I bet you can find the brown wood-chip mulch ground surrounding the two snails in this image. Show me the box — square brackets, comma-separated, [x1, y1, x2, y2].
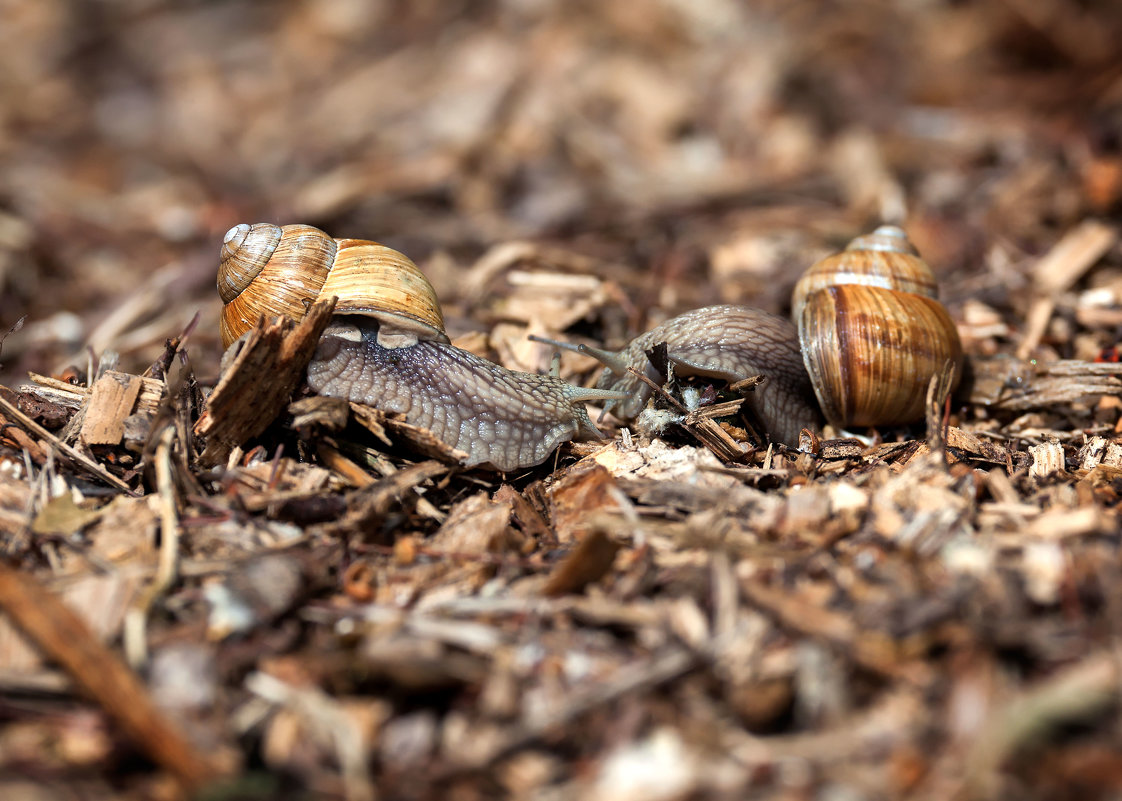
[0, 0, 1122, 801]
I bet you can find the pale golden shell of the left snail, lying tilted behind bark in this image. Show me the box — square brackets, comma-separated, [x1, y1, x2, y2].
[218, 223, 448, 348]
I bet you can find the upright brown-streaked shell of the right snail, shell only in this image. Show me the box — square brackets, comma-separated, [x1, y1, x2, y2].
[792, 225, 963, 426]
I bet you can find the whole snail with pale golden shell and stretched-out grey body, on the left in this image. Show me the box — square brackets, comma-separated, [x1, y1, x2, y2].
[218, 223, 624, 470]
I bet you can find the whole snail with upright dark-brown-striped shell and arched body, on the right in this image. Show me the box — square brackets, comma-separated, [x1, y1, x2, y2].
[535, 225, 963, 445]
